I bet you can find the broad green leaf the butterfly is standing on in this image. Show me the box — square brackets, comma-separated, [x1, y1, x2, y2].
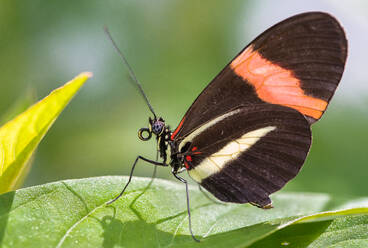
[0, 177, 368, 248]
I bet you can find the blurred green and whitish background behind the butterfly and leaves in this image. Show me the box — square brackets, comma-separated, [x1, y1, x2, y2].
[0, 0, 368, 196]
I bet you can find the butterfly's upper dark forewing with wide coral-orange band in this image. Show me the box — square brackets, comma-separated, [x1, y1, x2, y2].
[171, 12, 347, 140]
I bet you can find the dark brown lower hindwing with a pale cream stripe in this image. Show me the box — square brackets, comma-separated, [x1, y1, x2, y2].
[180, 103, 311, 206]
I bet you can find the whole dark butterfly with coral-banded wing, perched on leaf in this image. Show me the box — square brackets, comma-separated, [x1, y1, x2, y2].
[105, 12, 347, 239]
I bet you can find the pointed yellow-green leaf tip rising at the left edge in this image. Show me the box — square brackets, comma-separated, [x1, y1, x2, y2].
[0, 73, 92, 193]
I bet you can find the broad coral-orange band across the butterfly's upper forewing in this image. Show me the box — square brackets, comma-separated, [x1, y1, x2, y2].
[230, 46, 328, 119]
